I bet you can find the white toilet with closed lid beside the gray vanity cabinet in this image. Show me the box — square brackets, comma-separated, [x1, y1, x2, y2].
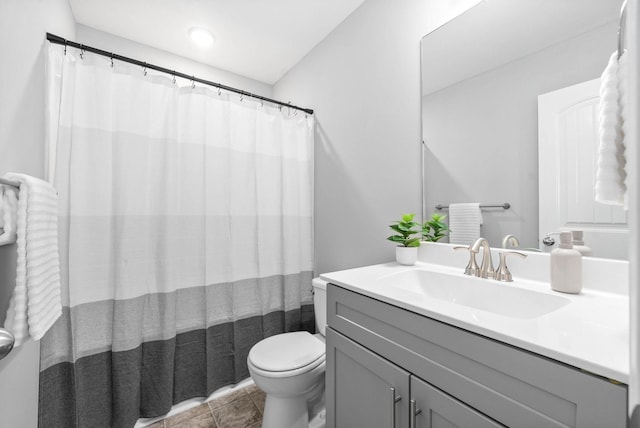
[247, 278, 327, 428]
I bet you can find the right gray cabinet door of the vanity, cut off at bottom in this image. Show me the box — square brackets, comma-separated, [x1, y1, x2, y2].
[409, 376, 504, 428]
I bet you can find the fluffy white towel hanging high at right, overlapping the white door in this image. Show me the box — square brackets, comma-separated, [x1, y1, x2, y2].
[595, 52, 628, 208]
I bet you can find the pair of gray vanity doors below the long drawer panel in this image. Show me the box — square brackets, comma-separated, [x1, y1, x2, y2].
[326, 328, 502, 428]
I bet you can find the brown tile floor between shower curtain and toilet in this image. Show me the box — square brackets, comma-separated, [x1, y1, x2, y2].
[147, 385, 265, 428]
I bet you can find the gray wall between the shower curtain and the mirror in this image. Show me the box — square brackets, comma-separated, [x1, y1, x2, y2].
[274, 0, 477, 273]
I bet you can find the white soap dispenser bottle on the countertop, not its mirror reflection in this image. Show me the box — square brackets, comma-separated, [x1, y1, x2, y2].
[551, 232, 582, 294]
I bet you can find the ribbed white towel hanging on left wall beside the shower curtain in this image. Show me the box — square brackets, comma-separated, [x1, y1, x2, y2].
[4, 173, 62, 346]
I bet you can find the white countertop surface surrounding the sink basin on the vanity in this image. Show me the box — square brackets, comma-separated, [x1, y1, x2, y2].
[320, 262, 629, 384]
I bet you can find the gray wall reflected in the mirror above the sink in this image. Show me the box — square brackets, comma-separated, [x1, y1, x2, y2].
[422, 23, 617, 247]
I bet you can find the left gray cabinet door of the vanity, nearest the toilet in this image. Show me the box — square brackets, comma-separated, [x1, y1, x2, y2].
[326, 328, 409, 428]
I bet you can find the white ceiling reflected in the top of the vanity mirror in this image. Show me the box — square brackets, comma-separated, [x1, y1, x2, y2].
[422, 0, 622, 95]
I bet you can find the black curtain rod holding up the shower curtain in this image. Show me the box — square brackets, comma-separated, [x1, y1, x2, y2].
[47, 33, 313, 114]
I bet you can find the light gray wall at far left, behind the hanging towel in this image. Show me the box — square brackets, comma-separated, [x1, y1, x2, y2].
[0, 0, 75, 428]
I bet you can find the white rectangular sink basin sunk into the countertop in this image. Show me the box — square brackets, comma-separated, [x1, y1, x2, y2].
[379, 269, 571, 319]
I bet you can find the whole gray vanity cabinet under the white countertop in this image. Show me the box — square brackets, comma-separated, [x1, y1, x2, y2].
[326, 284, 627, 428]
